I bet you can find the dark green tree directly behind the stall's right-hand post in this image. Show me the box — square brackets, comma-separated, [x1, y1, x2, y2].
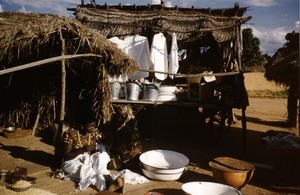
[242, 28, 265, 67]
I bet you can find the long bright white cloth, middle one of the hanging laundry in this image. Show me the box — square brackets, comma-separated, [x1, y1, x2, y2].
[150, 33, 168, 80]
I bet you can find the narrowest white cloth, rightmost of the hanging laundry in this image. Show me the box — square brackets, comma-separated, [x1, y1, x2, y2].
[169, 33, 179, 78]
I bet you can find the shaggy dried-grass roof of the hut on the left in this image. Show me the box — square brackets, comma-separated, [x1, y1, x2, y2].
[0, 12, 138, 74]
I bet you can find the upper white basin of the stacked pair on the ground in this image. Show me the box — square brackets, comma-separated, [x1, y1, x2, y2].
[139, 150, 189, 174]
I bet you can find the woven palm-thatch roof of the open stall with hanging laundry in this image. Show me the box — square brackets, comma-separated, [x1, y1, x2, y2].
[70, 4, 251, 45]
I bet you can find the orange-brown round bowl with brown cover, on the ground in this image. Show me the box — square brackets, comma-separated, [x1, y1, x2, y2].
[209, 157, 255, 188]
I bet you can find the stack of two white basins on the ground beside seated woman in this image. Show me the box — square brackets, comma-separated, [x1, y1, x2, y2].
[140, 150, 189, 181]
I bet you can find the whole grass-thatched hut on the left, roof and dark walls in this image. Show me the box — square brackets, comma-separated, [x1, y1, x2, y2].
[0, 12, 138, 131]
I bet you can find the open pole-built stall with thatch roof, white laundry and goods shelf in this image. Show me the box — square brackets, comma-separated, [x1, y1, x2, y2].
[69, 1, 251, 153]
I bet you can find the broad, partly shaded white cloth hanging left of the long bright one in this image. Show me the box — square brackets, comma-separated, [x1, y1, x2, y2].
[124, 35, 152, 80]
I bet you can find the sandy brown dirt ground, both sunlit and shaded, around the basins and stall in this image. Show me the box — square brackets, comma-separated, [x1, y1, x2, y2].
[0, 98, 300, 195]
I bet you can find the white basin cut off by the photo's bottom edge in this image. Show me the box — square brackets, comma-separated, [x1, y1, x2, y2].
[181, 181, 243, 195]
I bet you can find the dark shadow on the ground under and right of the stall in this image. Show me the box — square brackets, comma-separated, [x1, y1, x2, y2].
[141, 106, 300, 194]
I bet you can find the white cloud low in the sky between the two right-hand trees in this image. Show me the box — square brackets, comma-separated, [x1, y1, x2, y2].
[251, 26, 293, 55]
